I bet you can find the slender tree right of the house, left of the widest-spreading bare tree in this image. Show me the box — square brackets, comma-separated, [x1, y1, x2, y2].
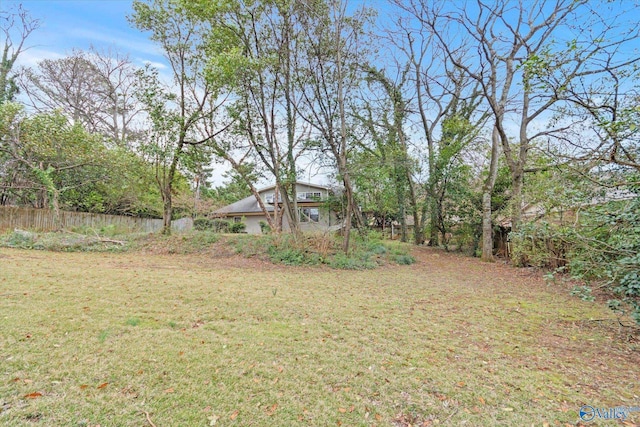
[386, 10, 486, 245]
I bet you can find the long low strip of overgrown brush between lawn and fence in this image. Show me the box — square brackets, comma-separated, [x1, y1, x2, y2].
[0, 228, 415, 270]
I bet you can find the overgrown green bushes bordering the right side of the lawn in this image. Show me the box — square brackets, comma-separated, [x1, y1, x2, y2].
[511, 180, 640, 324]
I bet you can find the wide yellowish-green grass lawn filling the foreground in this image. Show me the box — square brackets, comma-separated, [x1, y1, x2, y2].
[0, 249, 640, 427]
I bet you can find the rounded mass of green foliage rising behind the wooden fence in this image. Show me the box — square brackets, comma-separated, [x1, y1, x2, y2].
[0, 103, 159, 216]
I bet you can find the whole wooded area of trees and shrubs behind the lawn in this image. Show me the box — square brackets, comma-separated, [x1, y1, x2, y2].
[0, 0, 640, 319]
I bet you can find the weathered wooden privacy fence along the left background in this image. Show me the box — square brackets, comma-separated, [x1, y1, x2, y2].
[0, 206, 193, 233]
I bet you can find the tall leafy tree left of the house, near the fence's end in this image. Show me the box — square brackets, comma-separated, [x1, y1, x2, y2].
[130, 0, 234, 234]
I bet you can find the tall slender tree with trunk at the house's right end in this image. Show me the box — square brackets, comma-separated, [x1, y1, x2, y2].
[296, 0, 370, 252]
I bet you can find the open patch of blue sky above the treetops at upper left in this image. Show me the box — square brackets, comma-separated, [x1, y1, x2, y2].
[1, 0, 168, 67]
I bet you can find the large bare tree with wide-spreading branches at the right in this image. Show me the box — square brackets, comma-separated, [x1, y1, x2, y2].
[423, 0, 638, 237]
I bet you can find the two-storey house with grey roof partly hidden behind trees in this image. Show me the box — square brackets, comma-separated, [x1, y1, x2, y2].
[212, 182, 339, 234]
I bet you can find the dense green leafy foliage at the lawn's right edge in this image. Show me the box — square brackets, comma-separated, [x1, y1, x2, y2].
[513, 172, 640, 323]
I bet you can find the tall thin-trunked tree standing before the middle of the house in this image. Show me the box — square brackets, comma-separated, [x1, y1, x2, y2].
[220, 1, 309, 237]
